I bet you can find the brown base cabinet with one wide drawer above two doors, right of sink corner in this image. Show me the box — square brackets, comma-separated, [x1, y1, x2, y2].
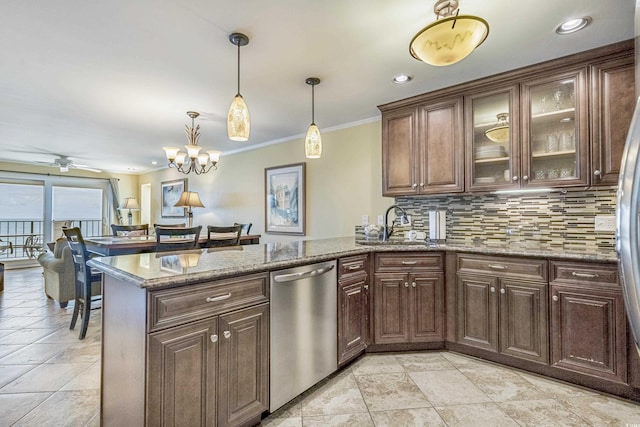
[457, 254, 549, 363]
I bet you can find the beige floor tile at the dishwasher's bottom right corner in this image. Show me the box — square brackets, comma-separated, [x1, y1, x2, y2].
[302, 374, 367, 417]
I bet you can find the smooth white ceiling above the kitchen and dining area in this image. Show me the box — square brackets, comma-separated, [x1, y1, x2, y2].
[0, 0, 634, 173]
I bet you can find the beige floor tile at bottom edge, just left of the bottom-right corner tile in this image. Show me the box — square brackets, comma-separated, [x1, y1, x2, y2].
[499, 399, 596, 427]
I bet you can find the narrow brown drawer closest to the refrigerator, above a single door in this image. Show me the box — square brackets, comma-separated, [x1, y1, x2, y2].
[550, 261, 620, 287]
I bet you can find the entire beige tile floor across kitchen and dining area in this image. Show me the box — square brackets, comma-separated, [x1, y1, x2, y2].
[0, 268, 640, 427]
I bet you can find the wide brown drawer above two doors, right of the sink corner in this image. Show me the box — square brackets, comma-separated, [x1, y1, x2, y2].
[458, 254, 549, 281]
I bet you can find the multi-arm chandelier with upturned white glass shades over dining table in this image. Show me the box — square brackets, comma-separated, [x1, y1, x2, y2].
[162, 111, 220, 175]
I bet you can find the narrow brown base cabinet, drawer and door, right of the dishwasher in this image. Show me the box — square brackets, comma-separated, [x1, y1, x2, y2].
[338, 255, 369, 366]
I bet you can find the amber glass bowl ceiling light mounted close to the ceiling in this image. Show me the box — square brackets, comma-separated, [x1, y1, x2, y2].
[409, 0, 489, 66]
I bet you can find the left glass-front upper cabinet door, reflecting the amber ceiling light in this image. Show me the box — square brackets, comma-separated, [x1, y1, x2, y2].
[465, 85, 520, 191]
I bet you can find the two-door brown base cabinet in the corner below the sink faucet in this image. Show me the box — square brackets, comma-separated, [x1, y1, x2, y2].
[374, 253, 444, 344]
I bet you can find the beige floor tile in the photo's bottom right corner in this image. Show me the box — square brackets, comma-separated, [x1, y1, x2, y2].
[561, 395, 640, 427]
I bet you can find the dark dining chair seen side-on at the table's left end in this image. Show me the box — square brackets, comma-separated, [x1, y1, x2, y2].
[62, 227, 102, 340]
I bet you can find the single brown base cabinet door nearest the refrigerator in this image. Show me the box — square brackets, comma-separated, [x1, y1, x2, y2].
[551, 285, 627, 382]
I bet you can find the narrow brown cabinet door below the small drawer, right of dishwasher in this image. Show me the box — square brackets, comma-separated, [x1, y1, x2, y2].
[338, 273, 367, 365]
